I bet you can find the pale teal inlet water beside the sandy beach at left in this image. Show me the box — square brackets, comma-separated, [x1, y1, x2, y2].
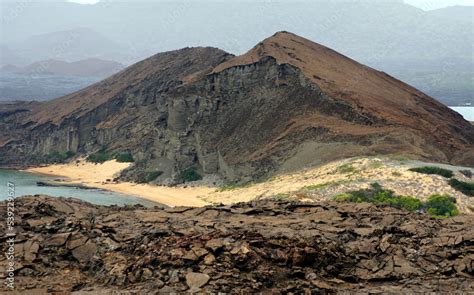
[0, 169, 156, 206]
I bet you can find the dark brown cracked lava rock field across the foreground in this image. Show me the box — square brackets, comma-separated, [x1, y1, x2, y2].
[0, 196, 474, 294]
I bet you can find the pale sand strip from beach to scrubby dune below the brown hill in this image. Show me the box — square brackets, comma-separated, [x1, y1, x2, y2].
[27, 157, 474, 214]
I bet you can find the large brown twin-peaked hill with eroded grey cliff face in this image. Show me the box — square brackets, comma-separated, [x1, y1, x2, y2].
[0, 32, 474, 182]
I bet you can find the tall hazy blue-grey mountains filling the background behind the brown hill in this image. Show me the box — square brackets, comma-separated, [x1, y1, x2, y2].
[0, 0, 474, 105]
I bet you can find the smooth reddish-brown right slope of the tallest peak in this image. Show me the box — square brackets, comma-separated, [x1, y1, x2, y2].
[214, 32, 472, 155]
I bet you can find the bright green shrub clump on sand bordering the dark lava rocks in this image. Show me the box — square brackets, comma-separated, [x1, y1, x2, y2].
[333, 183, 459, 218]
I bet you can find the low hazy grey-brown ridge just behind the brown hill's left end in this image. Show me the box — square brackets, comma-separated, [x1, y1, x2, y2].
[0, 58, 125, 77]
